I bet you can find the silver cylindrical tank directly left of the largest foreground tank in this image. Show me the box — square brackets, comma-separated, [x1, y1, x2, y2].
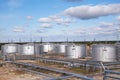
[65, 44, 86, 58]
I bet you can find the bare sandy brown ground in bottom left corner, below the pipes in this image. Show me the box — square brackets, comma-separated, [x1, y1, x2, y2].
[0, 66, 48, 80]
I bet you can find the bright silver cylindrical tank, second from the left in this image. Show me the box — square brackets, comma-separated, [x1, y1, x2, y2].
[21, 43, 35, 55]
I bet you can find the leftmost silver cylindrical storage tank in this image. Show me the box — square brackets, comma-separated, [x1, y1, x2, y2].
[2, 44, 18, 54]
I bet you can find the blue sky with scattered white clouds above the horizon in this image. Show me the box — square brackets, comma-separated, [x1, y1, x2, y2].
[0, 0, 120, 42]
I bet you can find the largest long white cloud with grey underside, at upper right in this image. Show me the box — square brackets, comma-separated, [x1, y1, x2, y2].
[64, 4, 120, 20]
